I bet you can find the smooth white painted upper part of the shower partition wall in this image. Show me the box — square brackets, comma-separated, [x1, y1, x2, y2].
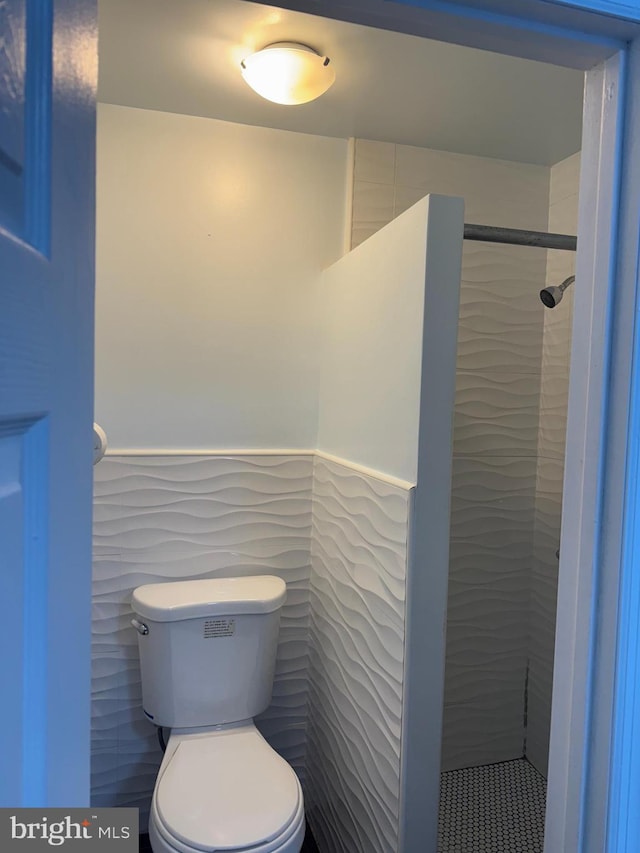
[318, 198, 460, 483]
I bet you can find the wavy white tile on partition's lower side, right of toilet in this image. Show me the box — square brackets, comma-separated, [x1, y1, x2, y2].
[307, 457, 411, 853]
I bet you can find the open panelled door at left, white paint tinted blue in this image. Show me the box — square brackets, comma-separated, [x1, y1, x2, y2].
[0, 0, 96, 807]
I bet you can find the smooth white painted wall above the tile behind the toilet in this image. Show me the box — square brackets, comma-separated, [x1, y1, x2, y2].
[96, 104, 348, 450]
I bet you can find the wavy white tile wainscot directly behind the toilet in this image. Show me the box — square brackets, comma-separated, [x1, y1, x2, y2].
[92, 455, 313, 827]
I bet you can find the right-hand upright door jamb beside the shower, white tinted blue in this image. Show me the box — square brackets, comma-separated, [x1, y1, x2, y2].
[545, 51, 633, 853]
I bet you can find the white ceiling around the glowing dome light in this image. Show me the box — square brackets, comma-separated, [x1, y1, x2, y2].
[98, 0, 583, 165]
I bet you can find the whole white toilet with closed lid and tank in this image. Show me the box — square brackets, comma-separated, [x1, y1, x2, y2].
[132, 576, 305, 853]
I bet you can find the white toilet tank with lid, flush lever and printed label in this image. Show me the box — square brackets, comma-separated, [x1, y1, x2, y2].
[132, 575, 286, 728]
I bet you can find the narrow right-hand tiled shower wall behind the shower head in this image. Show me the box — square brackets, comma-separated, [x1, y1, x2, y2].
[527, 154, 580, 776]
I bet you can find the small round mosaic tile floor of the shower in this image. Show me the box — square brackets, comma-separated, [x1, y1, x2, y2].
[438, 758, 547, 853]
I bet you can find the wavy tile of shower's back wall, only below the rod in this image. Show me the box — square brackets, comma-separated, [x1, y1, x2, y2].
[442, 244, 546, 770]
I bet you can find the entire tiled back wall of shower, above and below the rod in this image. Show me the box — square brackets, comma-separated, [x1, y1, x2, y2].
[352, 140, 549, 770]
